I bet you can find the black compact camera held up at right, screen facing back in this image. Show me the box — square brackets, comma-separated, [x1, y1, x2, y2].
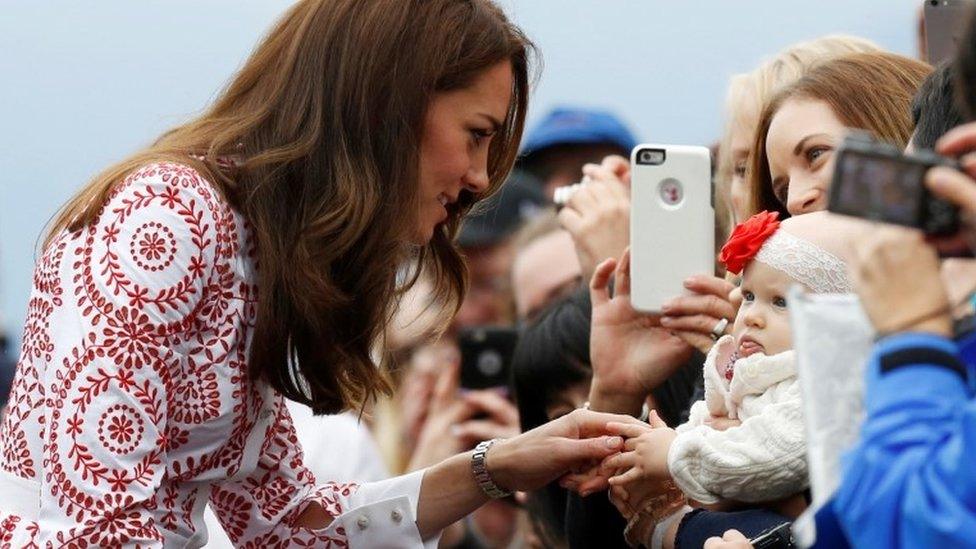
[827, 132, 959, 236]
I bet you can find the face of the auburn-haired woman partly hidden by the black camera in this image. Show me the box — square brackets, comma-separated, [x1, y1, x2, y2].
[766, 99, 847, 215]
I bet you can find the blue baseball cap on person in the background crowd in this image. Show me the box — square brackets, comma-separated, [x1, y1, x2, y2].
[521, 107, 637, 156]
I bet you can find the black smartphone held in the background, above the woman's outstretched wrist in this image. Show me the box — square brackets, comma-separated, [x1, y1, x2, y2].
[458, 326, 518, 389]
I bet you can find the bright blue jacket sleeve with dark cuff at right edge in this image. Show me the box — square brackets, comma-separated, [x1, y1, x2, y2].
[834, 334, 976, 548]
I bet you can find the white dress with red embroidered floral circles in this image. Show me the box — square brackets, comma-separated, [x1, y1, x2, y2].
[0, 164, 437, 549]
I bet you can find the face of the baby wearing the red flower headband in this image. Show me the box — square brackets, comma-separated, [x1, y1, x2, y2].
[732, 261, 793, 357]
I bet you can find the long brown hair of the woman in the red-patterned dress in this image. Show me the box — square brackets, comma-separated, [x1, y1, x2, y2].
[47, 0, 535, 413]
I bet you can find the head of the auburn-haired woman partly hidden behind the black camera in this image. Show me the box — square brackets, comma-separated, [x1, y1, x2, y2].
[749, 53, 932, 217]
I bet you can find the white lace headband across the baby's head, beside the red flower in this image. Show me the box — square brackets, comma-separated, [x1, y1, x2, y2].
[756, 229, 854, 294]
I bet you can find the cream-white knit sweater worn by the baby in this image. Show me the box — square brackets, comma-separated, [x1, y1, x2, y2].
[668, 336, 808, 503]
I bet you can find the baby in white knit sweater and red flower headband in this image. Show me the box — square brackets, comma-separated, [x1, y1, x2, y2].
[606, 212, 852, 544]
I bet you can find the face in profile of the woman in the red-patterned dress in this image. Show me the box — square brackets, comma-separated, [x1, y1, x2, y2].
[414, 61, 513, 245]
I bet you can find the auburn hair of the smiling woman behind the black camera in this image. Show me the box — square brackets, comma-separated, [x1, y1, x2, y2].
[747, 52, 932, 219]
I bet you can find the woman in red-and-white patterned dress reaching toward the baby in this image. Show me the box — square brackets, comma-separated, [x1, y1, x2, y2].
[0, 0, 621, 547]
